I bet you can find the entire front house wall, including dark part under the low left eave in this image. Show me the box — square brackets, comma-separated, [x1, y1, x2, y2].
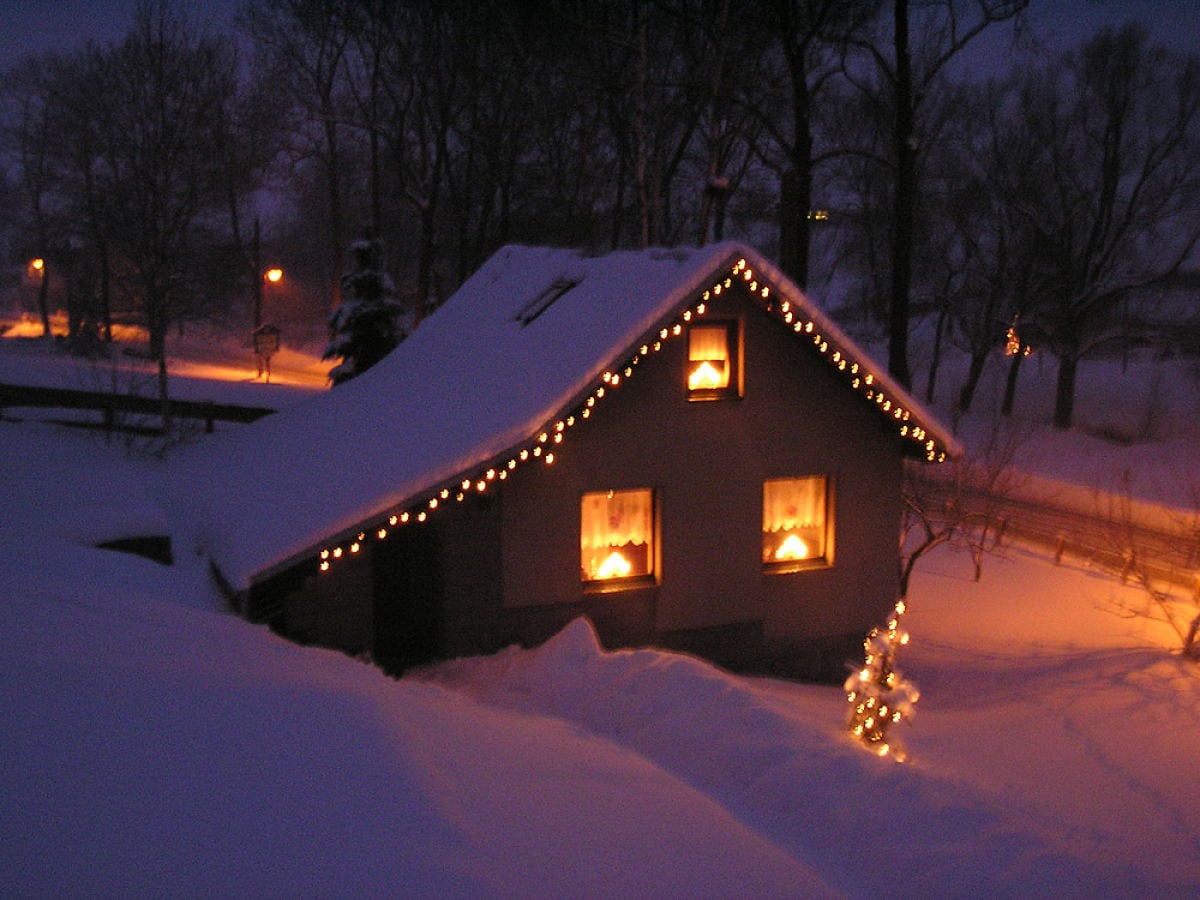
[270, 285, 901, 677]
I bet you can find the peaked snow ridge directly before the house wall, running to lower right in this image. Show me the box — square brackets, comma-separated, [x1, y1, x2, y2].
[427, 620, 1180, 896]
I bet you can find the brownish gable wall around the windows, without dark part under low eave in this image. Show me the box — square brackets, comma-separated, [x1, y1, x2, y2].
[502, 285, 901, 666]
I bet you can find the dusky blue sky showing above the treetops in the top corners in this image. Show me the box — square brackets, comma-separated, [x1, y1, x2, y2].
[0, 0, 1200, 78]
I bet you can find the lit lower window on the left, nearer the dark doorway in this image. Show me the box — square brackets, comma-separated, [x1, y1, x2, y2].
[580, 488, 654, 583]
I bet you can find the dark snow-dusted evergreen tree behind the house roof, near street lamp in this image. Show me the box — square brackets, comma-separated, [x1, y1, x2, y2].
[322, 234, 406, 385]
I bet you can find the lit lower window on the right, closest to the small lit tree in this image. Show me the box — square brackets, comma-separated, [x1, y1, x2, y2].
[762, 475, 832, 571]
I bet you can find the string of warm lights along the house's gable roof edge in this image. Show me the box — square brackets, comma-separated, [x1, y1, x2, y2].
[318, 258, 946, 571]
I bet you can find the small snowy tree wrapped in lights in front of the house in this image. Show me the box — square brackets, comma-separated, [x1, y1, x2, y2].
[846, 600, 919, 762]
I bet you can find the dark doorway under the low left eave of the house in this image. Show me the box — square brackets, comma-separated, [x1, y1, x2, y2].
[373, 524, 444, 674]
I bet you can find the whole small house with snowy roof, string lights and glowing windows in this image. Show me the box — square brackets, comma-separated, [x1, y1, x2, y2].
[184, 244, 958, 680]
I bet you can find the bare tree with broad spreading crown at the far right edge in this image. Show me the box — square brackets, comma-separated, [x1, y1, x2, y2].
[1012, 25, 1200, 428]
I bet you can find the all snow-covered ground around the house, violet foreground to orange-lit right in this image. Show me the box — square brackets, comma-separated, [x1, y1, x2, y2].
[0, 321, 1200, 896]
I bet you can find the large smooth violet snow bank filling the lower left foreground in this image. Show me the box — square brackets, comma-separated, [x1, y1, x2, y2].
[0, 551, 830, 896]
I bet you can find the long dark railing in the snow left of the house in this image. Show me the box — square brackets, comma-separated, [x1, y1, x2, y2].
[0, 384, 275, 432]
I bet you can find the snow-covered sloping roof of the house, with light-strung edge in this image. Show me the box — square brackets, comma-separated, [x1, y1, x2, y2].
[182, 242, 958, 590]
